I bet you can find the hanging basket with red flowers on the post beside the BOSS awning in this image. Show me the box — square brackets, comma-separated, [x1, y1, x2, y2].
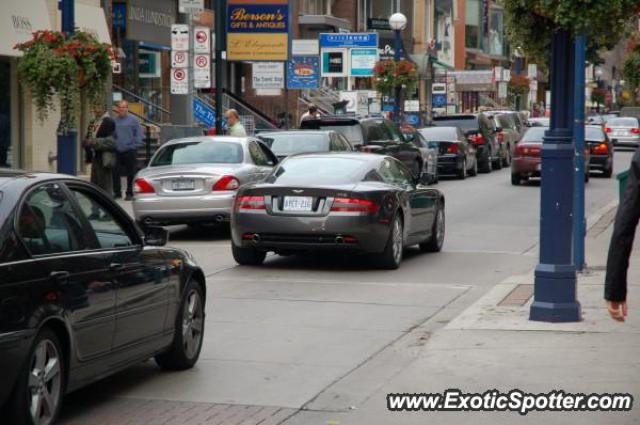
[15, 31, 111, 133]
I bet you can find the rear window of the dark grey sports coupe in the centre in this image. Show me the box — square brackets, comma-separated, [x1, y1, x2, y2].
[267, 156, 368, 186]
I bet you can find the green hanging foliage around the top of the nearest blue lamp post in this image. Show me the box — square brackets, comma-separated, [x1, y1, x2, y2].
[501, 0, 640, 64]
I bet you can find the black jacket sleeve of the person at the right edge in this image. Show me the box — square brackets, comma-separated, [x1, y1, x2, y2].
[604, 150, 640, 301]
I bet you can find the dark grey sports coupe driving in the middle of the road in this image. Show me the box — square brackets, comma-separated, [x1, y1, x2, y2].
[231, 153, 445, 269]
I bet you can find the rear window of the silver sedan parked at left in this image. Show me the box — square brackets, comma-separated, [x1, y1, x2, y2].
[151, 140, 243, 167]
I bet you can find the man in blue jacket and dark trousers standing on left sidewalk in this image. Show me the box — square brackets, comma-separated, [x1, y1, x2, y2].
[113, 100, 142, 201]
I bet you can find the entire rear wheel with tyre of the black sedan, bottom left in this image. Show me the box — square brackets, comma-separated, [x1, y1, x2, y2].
[9, 329, 66, 425]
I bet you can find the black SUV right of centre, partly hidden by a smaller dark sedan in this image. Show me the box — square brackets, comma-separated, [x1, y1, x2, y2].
[433, 113, 502, 173]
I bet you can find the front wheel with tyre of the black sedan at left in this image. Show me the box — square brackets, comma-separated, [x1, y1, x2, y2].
[156, 281, 204, 370]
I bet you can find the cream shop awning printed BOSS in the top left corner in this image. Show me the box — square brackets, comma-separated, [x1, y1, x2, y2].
[0, 0, 52, 56]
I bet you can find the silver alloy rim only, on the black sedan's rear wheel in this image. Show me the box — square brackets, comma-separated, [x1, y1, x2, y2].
[28, 339, 62, 425]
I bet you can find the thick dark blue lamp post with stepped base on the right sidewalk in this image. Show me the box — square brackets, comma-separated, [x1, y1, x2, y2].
[529, 30, 581, 322]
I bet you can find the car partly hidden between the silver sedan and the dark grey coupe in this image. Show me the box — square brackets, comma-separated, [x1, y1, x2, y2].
[258, 130, 353, 160]
